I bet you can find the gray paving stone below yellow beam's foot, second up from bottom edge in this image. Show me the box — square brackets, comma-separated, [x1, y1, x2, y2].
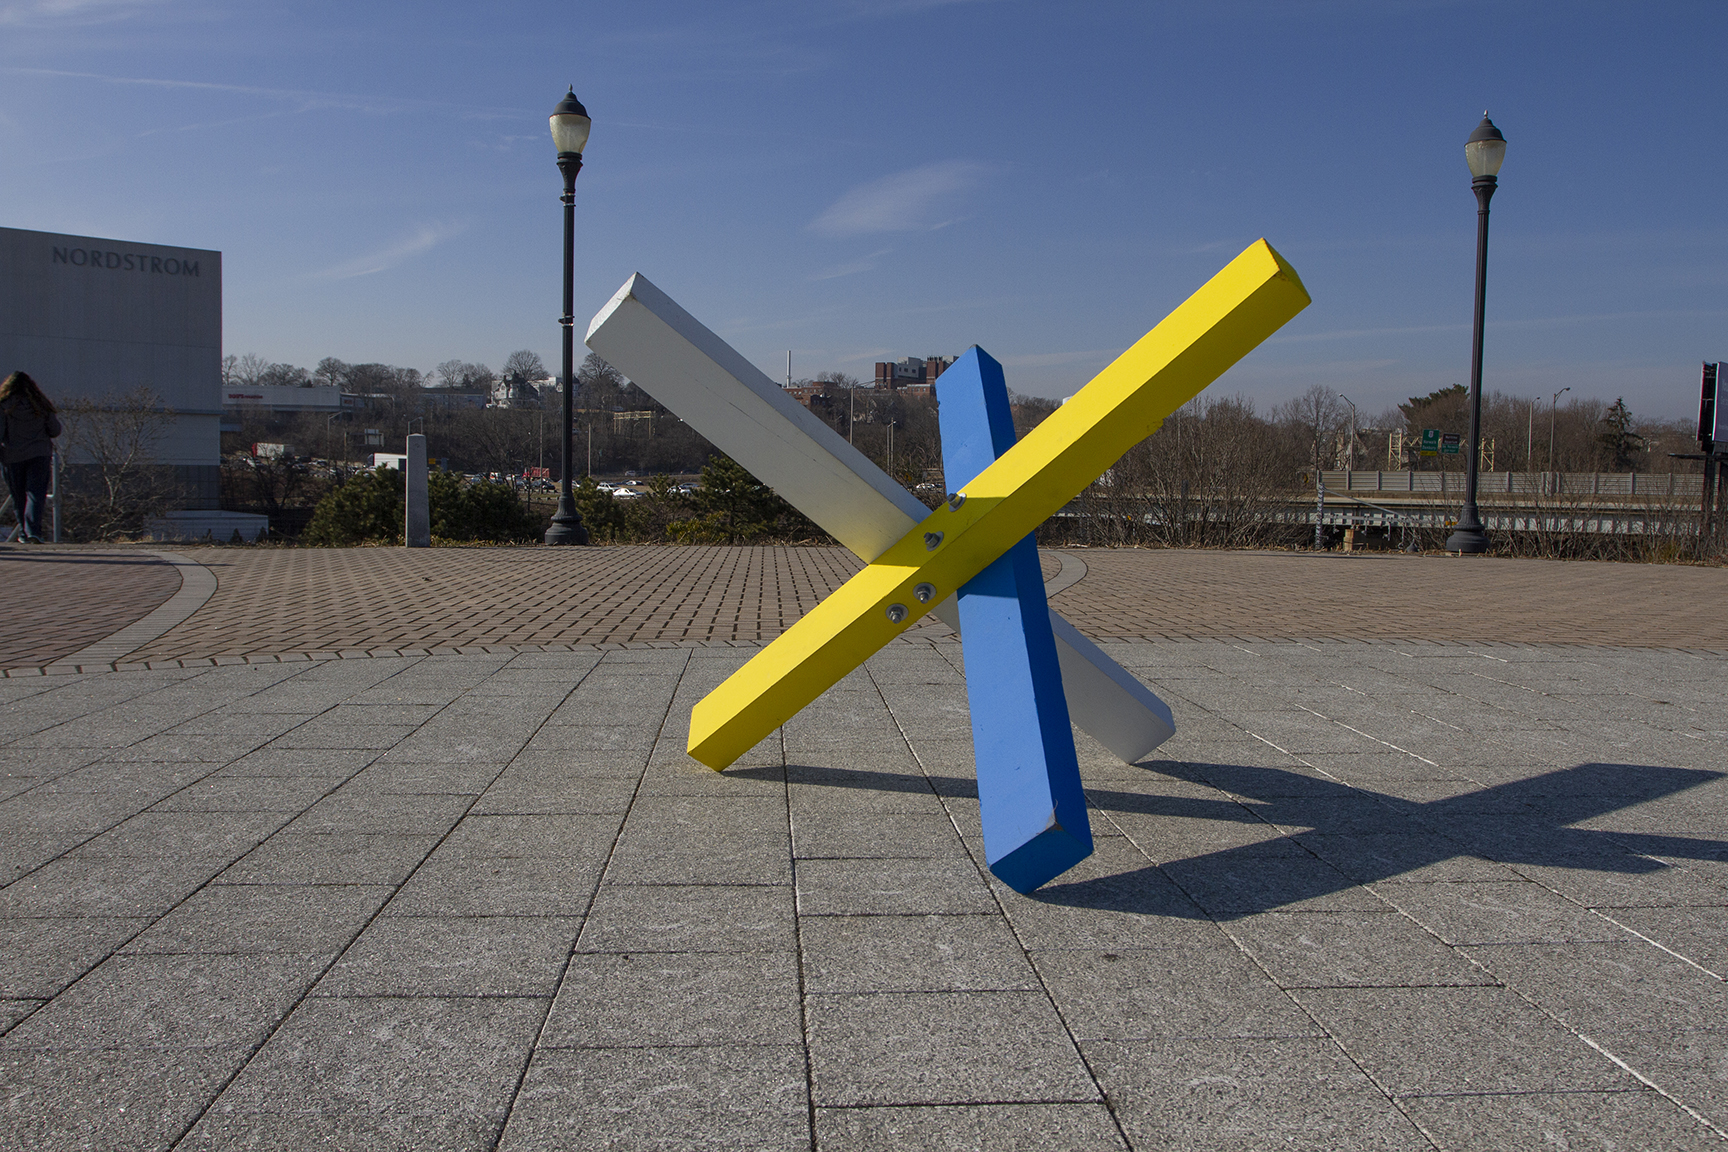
[541, 952, 804, 1048]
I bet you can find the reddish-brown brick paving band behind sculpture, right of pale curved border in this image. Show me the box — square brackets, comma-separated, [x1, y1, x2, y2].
[118, 546, 1728, 661]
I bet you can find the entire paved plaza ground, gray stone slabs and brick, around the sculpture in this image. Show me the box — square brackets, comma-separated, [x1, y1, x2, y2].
[0, 548, 1728, 1152]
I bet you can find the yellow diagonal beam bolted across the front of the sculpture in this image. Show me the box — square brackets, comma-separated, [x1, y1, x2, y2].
[689, 240, 1310, 770]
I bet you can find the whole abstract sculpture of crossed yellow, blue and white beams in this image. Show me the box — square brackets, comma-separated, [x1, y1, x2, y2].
[588, 240, 1308, 891]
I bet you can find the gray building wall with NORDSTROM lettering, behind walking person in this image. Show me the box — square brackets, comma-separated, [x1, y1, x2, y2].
[0, 228, 221, 508]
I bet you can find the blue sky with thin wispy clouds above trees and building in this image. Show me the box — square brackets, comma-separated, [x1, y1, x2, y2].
[0, 0, 1728, 418]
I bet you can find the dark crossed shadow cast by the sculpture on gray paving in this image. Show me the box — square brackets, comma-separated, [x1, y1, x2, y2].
[753, 762, 1728, 919]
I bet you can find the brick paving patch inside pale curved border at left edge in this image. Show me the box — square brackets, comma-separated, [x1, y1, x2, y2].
[0, 544, 180, 668]
